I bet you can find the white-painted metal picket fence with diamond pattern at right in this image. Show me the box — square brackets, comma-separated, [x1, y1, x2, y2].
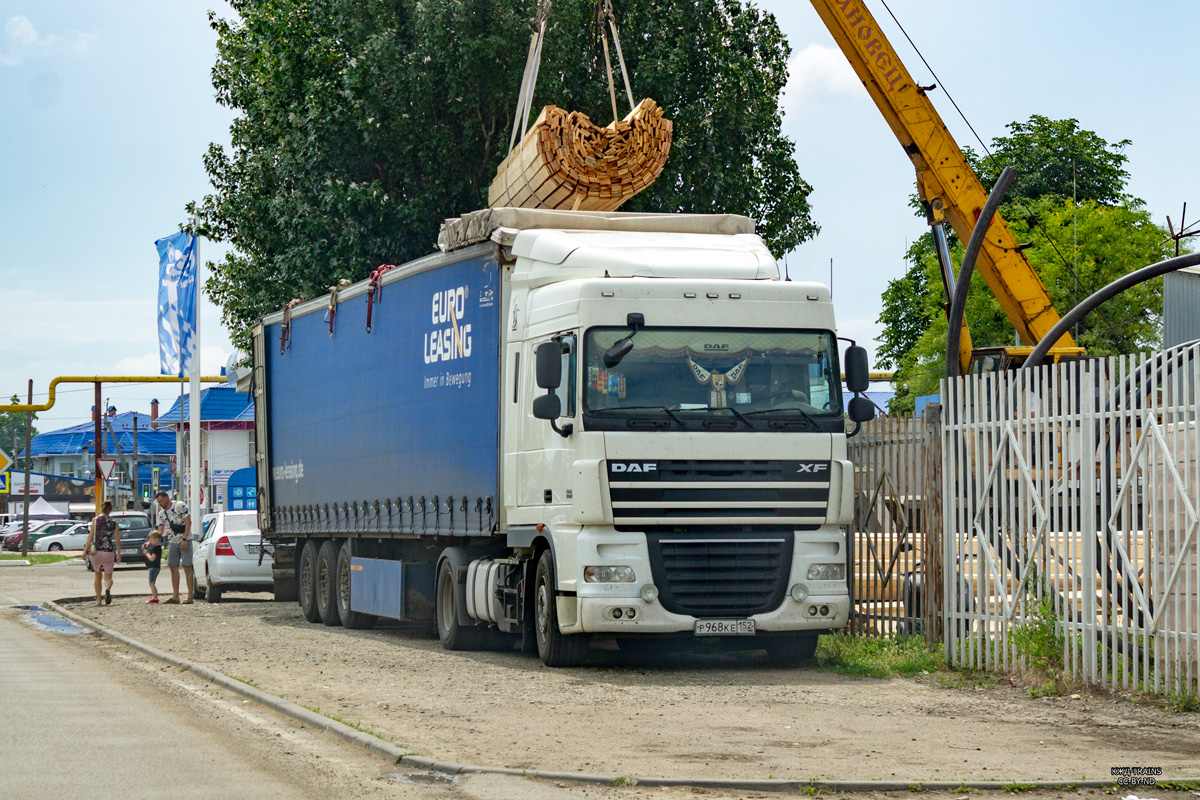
[940, 348, 1200, 694]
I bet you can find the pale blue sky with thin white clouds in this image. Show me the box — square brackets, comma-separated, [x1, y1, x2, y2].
[0, 0, 1200, 445]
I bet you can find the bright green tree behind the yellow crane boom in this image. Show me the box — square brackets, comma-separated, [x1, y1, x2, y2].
[876, 114, 1168, 411]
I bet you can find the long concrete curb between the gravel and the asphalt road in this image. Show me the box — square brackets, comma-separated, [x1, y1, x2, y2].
[47, 595, 1200, 794]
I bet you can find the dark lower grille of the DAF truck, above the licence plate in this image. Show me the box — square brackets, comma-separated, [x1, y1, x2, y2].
[647, 530, 792, 618]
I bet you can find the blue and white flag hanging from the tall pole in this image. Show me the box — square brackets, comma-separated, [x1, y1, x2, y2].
[155, 233, 199, 378]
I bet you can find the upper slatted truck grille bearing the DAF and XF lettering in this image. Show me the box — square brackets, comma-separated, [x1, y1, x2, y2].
[608, 461, 829, 533]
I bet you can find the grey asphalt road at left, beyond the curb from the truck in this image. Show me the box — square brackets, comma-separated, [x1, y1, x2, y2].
[0, 563, 686, 800]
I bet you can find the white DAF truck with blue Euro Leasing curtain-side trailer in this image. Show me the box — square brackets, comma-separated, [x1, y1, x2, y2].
[253, 209, 866, 666]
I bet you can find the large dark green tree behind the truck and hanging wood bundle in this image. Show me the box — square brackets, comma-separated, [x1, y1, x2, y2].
[188, 0, 817, 348]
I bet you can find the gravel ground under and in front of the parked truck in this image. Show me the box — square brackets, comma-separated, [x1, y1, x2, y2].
[65, 595, 1200, 796]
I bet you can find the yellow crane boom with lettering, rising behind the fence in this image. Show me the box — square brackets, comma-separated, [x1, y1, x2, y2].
[812, 0, 1082, 372]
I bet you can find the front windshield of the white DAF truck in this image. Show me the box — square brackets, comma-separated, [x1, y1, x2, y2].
[583, 327, 844, 432]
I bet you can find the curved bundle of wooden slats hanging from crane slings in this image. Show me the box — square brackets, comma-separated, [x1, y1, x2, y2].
[487, 97, 672, 211]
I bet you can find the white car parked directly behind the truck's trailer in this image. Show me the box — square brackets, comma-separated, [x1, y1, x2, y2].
[192, 511, 274, 603]
